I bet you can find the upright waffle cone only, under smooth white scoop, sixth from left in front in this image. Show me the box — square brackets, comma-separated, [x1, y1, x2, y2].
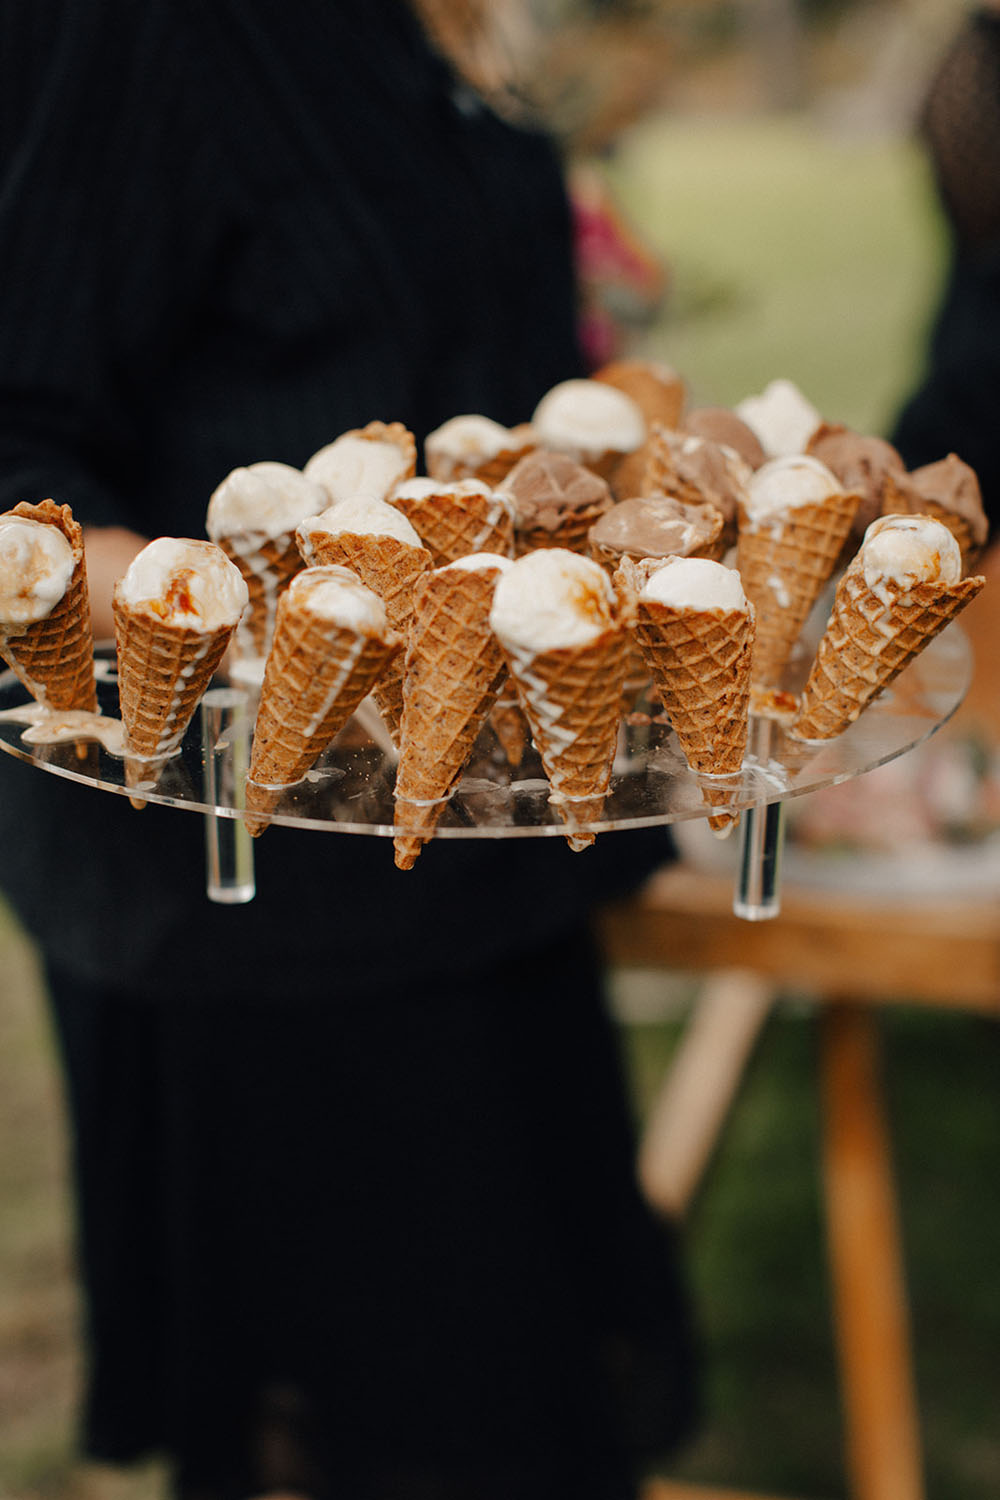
[634, 599, 754, 833]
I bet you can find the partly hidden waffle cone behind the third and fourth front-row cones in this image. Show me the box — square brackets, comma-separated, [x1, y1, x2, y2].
[293, 528, 432, 746]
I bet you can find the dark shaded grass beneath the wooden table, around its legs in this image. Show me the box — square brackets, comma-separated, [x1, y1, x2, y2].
[625, 996, 1000, 1500]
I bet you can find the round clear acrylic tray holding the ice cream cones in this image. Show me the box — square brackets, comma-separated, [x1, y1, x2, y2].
[0, 624, 972, 839]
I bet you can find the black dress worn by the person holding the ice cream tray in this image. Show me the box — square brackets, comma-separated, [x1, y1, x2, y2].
[0, 0, 691, 1500]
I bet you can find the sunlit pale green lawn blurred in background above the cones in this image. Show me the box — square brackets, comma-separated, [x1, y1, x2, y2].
[606, 117, 945, 432]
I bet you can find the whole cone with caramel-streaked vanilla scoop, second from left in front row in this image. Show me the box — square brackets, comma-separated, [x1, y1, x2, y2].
[112, 537, 247, 806]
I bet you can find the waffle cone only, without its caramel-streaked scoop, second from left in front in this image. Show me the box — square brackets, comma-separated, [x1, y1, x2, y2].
[112, 591, 234, 789]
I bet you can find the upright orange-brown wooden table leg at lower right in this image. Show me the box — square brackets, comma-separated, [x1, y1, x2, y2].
[822, 1002, 924, 1500]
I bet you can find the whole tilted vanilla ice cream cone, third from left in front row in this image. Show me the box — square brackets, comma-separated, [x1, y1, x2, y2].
[246, 567, 403, 836]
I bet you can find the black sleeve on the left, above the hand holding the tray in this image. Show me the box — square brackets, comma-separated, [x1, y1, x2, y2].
[0, 0, 233, 527]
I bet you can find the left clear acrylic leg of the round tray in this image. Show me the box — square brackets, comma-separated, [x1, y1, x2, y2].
[201, 687, 256, 906]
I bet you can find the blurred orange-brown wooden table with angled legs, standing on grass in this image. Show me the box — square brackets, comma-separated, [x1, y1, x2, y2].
[601, 866, 1000, 1500]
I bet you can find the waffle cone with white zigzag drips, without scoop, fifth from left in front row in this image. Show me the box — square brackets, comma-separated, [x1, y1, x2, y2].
[507, 626, 628, 849]
